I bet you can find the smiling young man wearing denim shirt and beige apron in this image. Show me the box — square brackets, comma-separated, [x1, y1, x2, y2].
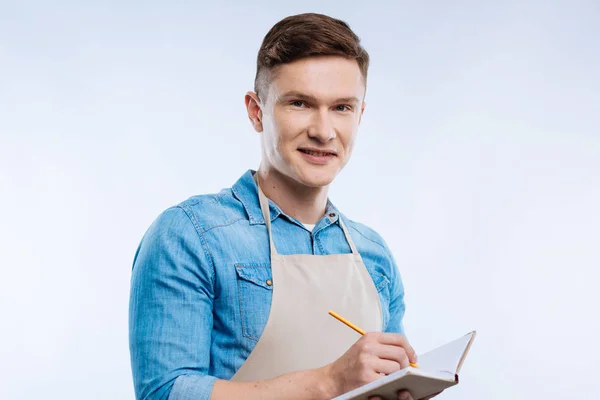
[130, 14, 434, 400]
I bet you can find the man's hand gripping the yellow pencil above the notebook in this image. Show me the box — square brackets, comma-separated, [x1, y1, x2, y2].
[324, 332, 417, 397]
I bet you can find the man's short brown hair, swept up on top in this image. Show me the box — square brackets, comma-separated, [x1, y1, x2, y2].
[254, 13, 369, 101]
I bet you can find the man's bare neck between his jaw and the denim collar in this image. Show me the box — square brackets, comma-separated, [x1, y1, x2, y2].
[257, 164, 329, 224]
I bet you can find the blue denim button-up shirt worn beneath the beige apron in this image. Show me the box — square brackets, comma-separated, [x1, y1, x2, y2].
[129, 171, 405, 400]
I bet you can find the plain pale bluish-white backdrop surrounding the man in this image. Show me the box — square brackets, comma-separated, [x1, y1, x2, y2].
[0, 1, 600, 400]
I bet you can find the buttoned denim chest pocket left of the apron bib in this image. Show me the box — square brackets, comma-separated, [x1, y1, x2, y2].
[235, 264, 273, 341]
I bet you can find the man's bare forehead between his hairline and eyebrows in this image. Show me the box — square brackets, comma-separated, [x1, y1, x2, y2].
[269, 56, 365, 101]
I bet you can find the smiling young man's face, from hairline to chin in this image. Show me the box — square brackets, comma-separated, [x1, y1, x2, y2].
[251, 56, 365, 187]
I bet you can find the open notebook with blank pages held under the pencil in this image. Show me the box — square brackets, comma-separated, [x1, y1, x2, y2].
[333, 332, 475, 400]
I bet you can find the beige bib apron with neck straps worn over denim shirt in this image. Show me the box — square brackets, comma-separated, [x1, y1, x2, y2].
[231, 174, 382, 381]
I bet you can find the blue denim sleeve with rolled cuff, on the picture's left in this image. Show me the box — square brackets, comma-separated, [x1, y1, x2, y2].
[129, 207, 217, 400]
